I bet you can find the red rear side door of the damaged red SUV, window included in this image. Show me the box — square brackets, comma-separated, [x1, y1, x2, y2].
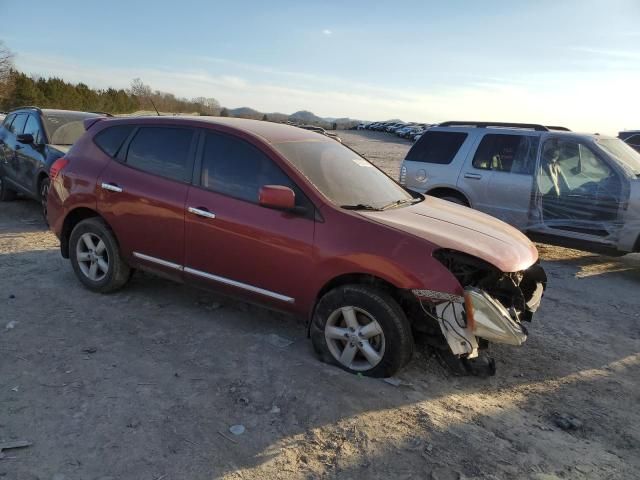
[96, 126, 196, 277]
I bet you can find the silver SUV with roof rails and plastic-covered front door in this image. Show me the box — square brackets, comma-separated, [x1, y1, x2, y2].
[400, 121, 640, 253]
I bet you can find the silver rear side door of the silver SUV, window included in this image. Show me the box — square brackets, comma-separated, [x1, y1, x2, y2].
[458, 132, 539, 230]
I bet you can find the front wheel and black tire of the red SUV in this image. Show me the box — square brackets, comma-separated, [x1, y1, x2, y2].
[311, 285, 414, 377]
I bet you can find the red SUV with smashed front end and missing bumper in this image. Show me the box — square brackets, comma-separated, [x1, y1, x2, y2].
[48, 117, 546, 376]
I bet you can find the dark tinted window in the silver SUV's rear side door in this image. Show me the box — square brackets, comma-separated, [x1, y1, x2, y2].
[473, 134, 538, 174]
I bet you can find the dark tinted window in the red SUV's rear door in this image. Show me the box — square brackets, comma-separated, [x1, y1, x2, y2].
[126, 127, 194, 181]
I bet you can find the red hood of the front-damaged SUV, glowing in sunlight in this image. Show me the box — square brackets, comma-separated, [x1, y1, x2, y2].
[358, 197, 538, 272]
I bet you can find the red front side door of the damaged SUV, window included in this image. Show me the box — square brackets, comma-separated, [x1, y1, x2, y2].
[185, 132, 315, 309]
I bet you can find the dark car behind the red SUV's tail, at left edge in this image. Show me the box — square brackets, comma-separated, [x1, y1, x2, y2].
[0, 107, 101, 217]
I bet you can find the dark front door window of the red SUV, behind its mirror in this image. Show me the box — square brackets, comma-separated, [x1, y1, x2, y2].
[200, 133, 302, 204]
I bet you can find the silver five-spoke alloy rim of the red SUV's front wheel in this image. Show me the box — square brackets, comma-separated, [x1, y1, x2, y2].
[324, 306, 385, 371]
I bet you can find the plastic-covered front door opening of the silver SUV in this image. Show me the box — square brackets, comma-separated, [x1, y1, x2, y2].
[536, 138, 627, 237]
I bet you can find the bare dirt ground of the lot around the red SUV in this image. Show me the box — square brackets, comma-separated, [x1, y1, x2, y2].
[0, 132, 640, 480]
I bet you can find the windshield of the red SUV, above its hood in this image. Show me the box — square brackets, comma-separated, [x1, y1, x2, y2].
[274, 141, 413, 209]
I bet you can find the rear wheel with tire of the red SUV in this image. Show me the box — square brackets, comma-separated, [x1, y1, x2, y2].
[69, 217, 131, 293]
